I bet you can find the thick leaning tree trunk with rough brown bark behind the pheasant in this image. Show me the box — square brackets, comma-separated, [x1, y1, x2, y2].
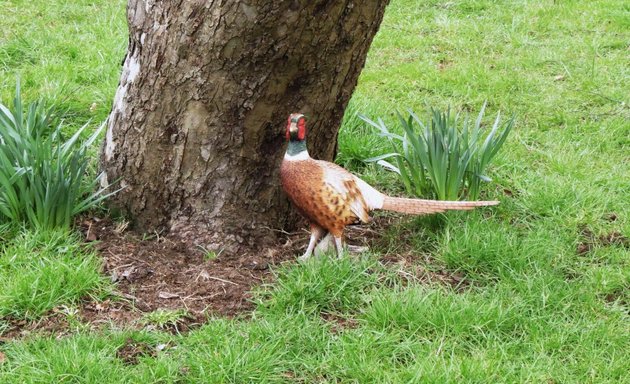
[101, 0, 388, 251]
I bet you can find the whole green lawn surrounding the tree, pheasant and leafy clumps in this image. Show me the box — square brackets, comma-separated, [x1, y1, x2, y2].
[0, 0, 630, 383]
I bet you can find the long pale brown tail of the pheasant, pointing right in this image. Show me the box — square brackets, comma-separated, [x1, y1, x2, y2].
[382, 196, 499, 215]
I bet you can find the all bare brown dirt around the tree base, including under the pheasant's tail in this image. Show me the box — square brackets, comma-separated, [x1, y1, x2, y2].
[0, 215, 474, 341]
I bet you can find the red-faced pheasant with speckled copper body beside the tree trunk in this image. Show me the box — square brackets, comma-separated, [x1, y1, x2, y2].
[280, 113, 499, 260]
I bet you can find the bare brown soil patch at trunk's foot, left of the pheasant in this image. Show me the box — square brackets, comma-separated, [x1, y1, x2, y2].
[82, 220, 304, 324]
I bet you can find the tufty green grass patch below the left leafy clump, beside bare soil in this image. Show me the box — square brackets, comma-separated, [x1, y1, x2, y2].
[0, 230, 107, 320]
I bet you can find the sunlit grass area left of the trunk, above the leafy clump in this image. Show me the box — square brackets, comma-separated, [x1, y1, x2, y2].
[0, 0, 127, 127]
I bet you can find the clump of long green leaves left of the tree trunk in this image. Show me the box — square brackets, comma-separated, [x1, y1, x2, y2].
[0, 81, 115, 228]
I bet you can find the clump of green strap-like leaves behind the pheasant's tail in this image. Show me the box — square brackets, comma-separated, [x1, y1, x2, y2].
[360, 104, 514, 200]
